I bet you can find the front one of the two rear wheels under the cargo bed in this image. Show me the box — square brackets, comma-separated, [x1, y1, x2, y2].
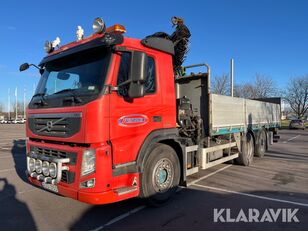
[235, 133, 254, 166]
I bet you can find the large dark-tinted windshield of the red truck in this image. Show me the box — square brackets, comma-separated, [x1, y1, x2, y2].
[35, 47, 110, 99]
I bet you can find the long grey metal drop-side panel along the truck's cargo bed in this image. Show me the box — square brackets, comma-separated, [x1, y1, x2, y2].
[210, 94, 280, 135]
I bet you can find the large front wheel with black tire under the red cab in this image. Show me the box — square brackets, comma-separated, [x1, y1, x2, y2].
[140, 143, 180, 207]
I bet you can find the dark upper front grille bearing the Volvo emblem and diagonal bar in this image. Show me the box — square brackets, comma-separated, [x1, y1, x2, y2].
[28, 113, 81, 137]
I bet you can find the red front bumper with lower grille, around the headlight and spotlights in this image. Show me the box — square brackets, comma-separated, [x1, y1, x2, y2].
[27, 140, 139, 204]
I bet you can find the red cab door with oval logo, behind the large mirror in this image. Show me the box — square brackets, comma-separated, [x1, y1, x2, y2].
[110, 52, 163, 165]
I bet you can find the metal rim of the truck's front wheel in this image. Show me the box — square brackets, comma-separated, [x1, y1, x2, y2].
[152, 158, 174, 193]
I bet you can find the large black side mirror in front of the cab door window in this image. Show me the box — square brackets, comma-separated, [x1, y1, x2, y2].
[128, 51, 148, 98]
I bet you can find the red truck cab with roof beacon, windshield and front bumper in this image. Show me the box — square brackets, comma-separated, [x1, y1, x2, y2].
[26, 19, 176, 204]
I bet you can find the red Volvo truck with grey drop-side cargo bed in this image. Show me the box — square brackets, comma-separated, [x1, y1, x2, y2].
[20, 18, 280, 204]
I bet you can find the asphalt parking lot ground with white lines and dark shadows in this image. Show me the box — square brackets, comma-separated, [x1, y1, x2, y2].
[0, 124, 308, 231]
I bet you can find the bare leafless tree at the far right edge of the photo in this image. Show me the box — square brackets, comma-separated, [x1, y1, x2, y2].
[284, 74, 308, 118]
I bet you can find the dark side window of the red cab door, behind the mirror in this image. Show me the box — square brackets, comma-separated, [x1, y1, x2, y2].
[117, 52, 156, 97]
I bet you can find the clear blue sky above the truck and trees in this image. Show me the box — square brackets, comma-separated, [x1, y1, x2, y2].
[0, 0, 308, 110]
